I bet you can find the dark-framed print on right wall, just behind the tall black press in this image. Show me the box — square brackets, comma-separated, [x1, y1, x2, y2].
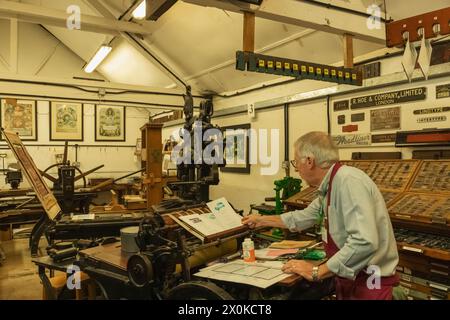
[220, 123, 250, 173]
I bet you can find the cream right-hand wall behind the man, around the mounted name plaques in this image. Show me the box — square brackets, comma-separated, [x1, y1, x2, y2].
[163, 57, 450, 212]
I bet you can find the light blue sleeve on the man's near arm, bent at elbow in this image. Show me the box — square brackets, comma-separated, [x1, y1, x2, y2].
[327, 176, 379, 279]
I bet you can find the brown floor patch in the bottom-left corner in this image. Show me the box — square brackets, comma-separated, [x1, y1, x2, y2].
[0, 239, 45, 300]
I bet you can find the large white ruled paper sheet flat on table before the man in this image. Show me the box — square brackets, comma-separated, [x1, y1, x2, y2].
[195, 260, 291, 289]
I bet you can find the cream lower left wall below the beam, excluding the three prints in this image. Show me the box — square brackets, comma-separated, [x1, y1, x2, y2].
[0, 101, 149, 188]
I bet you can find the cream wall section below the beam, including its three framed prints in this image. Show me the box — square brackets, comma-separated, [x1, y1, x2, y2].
[0, 97, 148, 188]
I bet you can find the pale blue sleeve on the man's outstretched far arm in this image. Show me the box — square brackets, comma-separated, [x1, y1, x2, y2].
[280, 197, 321, 231]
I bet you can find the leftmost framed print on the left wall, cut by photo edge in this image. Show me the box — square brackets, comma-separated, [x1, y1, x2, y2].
[0, 99, 37, 141]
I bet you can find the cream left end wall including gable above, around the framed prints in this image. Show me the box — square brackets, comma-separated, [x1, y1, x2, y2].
[0, 19, 173, 189]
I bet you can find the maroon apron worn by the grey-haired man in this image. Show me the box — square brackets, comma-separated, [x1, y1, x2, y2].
[324, 162, 399, 300]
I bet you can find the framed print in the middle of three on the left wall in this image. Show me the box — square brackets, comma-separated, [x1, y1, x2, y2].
[50, 101, 83, 141]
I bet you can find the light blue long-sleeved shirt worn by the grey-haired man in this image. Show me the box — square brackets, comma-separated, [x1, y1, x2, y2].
[281, 166, 398, 279]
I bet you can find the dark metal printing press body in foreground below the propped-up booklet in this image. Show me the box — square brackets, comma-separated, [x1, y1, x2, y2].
[74, 206, 249, 300]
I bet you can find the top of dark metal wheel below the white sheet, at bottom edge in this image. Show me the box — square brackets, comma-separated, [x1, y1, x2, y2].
[167, 281, 234, 300]
